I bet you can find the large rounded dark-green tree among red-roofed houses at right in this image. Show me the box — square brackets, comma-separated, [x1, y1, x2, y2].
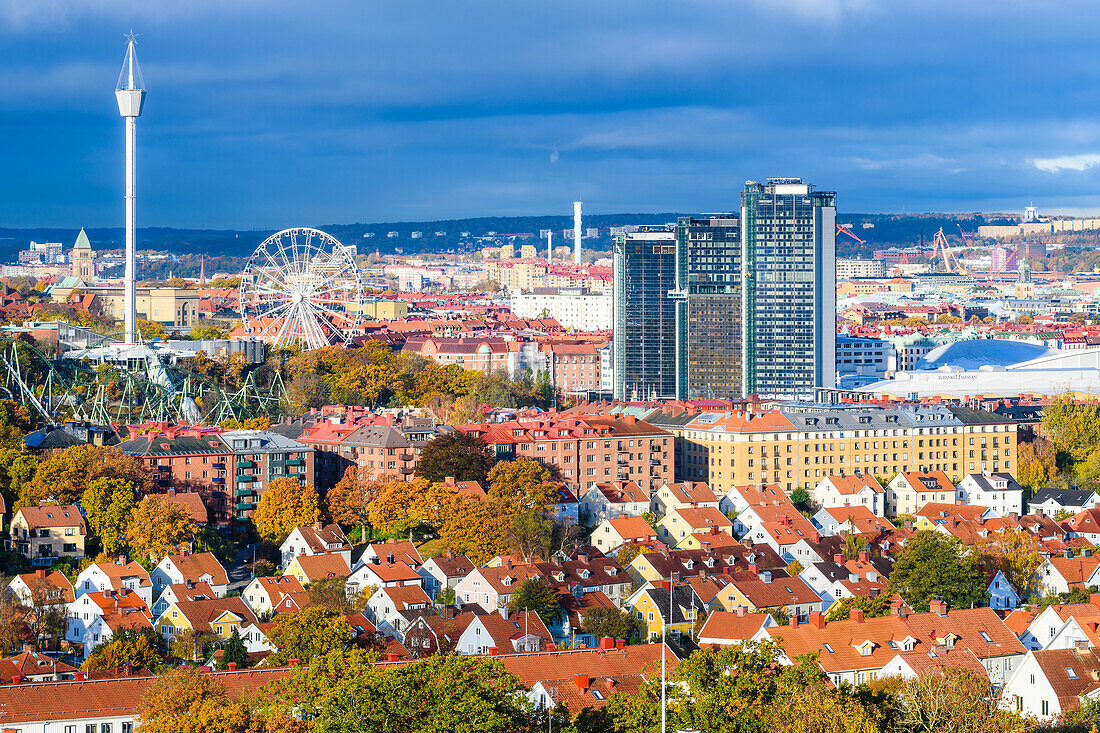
[890, 529, 987, 611]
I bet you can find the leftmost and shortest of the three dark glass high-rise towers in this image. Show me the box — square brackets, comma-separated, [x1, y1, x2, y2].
[614, 226, 677, 400]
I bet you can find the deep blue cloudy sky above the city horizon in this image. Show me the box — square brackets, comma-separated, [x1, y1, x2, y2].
[0, 0, 1100, 228]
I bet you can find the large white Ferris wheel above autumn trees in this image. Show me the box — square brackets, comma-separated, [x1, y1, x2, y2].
[240, 229, 363, 349]
